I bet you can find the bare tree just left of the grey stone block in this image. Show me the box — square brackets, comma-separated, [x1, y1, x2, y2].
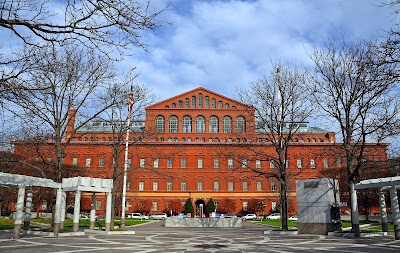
[238, 64, 312, 230]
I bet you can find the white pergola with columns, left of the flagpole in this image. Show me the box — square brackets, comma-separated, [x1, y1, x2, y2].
[0, 172, 113, 239]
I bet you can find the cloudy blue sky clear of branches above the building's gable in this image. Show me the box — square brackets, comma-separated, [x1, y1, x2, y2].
[124, 0, 394, 100]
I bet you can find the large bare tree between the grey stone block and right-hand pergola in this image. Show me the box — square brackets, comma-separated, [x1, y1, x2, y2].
[310, 39, 400, 236]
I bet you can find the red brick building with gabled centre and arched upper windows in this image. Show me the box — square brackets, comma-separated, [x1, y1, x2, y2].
[11, 88, 387, 214]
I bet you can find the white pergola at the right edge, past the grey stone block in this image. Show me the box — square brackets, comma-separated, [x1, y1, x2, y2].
[355, 176, 400, 240]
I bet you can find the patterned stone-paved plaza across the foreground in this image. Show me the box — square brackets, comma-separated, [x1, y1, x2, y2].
[0, 221, 400, 253]
